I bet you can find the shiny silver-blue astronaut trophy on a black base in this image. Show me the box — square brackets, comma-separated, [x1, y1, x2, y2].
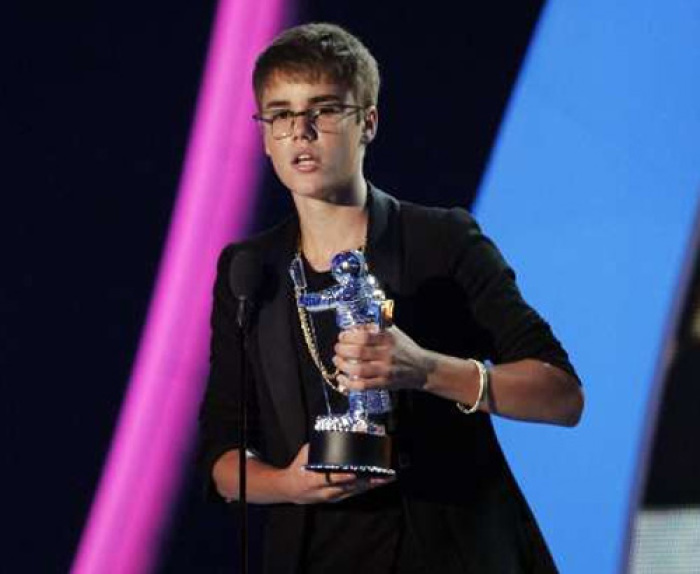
[290, 250, 395, 476]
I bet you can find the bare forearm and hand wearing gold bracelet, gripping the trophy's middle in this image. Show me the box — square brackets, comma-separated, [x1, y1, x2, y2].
[333, 326, 584, 426]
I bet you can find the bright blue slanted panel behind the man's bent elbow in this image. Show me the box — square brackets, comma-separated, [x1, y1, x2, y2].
[475, 0, 700, 574]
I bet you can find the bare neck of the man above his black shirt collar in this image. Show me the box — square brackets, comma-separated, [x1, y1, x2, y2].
[295, 181, 368, 271]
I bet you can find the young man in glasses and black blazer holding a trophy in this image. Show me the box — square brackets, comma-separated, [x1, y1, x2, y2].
[201, 24, 583, 574]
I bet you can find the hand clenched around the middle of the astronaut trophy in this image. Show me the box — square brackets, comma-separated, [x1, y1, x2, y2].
[333, 326, 435, 391]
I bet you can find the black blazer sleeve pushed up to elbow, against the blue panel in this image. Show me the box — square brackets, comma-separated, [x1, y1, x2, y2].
[445, 208, 580, 382]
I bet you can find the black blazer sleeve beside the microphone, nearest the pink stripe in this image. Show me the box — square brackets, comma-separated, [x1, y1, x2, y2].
[198, 246, 258, 497]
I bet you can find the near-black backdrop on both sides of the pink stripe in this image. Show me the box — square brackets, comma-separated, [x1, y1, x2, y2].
[0, 0, 542, 573]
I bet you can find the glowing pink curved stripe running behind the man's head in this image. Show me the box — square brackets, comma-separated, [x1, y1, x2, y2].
[72, 0, 290, 574]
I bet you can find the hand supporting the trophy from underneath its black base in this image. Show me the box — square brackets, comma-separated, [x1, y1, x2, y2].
[283, 443, 394, 504]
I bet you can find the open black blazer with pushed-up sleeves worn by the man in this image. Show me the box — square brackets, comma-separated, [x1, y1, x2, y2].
[200, 186, 575, 574]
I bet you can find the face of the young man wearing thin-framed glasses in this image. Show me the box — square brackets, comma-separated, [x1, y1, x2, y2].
[260, 74, 377, 199]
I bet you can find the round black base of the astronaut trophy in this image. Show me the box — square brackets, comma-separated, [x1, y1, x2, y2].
[306, 431, 396, 476]
